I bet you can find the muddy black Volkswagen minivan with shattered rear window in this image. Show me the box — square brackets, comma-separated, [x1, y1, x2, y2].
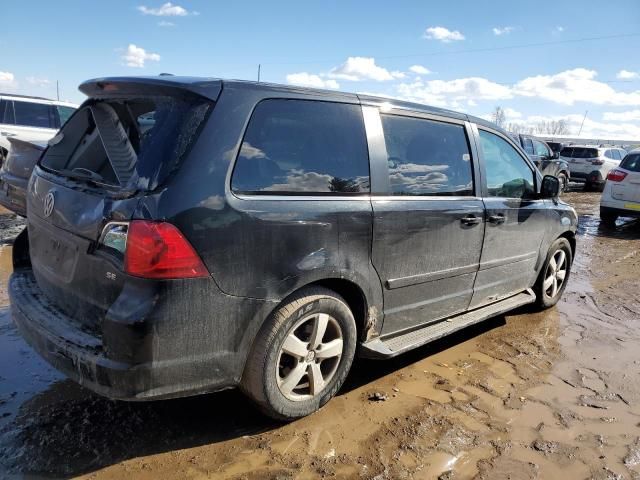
[9, 76, 577, 419]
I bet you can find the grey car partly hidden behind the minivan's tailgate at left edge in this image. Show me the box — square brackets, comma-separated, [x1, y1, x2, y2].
[0, 137, 47, 217]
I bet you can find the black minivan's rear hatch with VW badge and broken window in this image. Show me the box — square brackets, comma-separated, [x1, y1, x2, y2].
[27, 79, 219, 334]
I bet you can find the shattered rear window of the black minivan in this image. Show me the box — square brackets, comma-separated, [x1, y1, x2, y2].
[41, 96, 211, 190]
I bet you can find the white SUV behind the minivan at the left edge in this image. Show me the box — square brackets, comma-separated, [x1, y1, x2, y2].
[0, 94, 78, 164]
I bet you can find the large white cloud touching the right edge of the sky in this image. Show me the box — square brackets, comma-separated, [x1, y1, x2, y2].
[513, 68, 640, 105]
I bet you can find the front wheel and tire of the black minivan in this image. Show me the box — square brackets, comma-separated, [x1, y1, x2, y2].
[534, 238, 573, 309]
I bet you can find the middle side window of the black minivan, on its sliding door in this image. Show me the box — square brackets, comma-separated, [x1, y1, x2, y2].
[381, 115, 473, 196]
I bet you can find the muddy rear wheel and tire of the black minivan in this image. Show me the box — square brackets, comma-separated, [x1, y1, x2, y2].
[240, 287, 357, 421]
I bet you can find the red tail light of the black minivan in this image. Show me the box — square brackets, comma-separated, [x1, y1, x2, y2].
[124, 220, 209, 279]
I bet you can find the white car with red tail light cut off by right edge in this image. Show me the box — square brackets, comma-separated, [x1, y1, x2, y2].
[600, 150, 640, 226]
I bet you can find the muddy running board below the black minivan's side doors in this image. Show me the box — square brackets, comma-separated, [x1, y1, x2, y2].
[360, 289, 536, 358]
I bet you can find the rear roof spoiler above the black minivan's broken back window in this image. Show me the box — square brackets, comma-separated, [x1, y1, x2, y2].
[78, 75, 222, 102]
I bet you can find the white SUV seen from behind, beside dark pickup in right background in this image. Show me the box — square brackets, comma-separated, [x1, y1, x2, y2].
[560, 145, 627, 190]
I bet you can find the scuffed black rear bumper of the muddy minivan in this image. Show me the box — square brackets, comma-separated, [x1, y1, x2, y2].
[9, 269, 272, 400]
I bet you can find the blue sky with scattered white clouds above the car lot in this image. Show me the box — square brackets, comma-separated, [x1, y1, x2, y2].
[0, 0, 640, 139]
